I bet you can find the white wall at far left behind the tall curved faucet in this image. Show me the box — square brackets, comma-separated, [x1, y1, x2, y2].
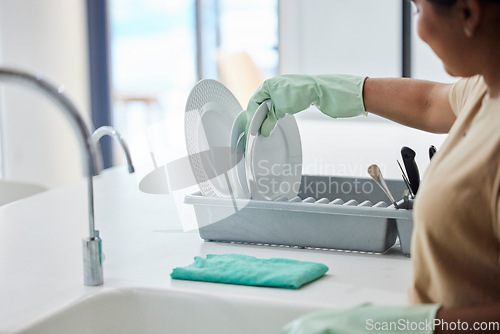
[0, 0, 90, 187]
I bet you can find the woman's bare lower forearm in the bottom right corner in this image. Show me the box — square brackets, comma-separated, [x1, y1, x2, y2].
[434, 304, 500, 334]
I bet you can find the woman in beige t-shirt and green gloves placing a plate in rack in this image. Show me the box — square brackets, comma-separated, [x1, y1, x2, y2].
[247, 0, 500, 333]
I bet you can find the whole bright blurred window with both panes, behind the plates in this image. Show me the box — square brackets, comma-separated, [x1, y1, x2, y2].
[110, 0, 278, 166]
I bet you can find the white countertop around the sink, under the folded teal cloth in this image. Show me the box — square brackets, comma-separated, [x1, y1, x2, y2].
[0, 167, 412, 333]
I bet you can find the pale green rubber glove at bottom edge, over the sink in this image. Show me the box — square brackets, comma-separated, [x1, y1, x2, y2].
[281, 304, 439, 334]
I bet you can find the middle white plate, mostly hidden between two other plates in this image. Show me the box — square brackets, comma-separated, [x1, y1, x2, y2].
[229, 111, 250, 198]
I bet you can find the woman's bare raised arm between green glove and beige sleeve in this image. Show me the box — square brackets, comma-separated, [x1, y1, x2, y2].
[363, 78, 456, 133]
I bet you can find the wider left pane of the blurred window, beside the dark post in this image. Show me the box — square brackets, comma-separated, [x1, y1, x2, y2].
[110, 0, 197, 133]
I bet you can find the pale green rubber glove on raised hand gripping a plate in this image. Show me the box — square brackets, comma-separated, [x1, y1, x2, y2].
[245, 74, 366, 137]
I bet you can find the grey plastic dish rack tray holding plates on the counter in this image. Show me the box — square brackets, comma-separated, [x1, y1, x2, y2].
[184, 175, 413, 255]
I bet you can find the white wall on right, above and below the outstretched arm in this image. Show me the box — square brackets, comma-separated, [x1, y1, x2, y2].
[279, 0, 450, 180]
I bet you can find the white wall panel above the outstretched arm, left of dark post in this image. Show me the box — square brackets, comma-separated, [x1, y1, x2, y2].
[279, 0, 401, 77]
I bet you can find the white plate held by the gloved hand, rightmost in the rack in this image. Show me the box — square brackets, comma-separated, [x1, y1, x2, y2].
[245, 103, 302, 200]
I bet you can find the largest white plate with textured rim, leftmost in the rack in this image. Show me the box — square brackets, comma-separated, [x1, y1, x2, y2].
[184, 79, 243, 197]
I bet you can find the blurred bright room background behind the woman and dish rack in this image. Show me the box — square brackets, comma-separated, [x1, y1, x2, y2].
[0, 0, 456, 193]
